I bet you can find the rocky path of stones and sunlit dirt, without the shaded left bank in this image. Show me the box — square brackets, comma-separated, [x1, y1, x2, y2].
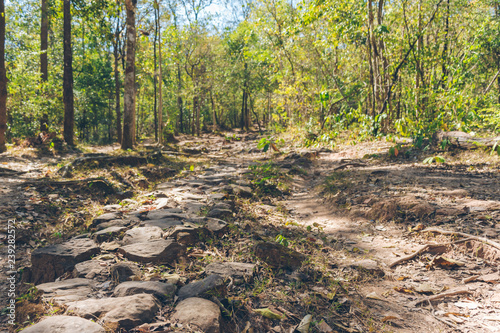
[2, 135, 500, 333]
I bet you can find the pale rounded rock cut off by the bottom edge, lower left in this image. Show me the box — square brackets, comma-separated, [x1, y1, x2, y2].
[22, 316, 106, 333]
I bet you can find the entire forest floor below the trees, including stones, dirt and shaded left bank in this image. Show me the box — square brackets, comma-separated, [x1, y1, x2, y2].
[0, 132, 500, 333]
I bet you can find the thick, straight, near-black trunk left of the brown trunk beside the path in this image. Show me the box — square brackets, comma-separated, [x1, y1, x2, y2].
[63, 0, 75, 146]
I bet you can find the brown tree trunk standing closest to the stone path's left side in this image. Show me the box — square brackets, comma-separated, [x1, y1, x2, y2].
[122, 0, 137, 150]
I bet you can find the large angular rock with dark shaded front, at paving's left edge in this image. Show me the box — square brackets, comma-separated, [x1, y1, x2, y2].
[31, 238, 100, 284]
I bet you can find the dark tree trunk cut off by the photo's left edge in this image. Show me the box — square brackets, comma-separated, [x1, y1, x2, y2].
[0, 0, 7, 153]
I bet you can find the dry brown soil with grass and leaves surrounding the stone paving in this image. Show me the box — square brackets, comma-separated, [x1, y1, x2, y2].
[0, 132, 500, 333]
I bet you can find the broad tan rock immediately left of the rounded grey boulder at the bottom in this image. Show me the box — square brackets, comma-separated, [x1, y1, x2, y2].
[66, 294, 158, 330]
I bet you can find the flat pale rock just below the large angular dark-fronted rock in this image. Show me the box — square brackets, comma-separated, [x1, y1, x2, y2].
[36, 278, 95, 306]
